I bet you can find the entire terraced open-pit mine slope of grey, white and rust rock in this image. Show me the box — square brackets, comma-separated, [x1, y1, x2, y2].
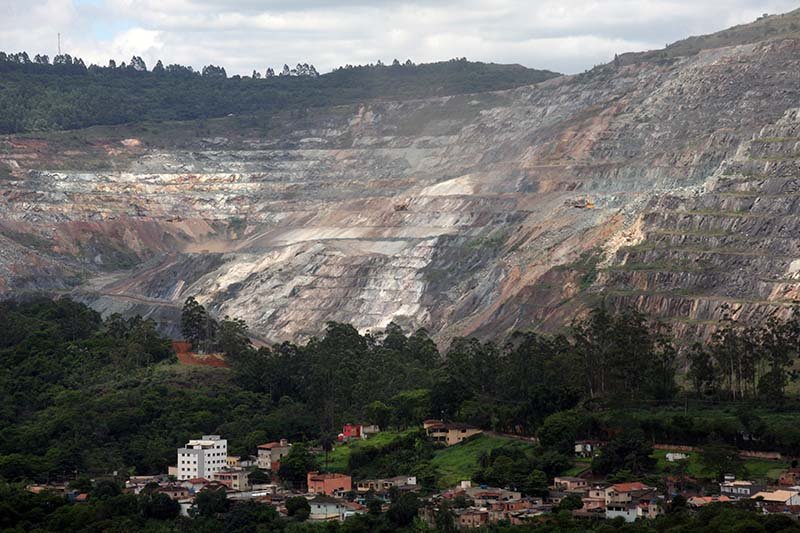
[0, 35, 800, 341]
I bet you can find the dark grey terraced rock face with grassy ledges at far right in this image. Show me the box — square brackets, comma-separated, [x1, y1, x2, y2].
[602, 109, 800, 337]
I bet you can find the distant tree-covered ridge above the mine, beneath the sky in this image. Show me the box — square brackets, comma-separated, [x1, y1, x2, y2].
[0, 52, 556, 134]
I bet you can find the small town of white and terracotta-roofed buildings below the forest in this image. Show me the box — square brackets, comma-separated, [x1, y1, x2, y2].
[20, 420, 800, 530]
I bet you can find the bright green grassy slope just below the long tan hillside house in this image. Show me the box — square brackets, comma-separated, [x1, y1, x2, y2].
[431, 434, 533, 487]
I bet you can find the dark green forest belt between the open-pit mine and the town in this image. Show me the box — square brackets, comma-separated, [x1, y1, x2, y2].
[0, 299, 800, 481]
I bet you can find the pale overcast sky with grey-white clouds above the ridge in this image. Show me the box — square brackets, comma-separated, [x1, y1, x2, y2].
[0, 0, 800, 74]
